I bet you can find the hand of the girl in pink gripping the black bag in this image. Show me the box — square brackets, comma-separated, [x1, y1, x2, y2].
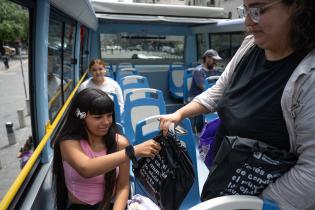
[134, 140, 161, 157]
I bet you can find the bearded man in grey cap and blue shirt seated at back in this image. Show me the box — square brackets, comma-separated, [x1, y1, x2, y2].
[189, 49, 222, 98]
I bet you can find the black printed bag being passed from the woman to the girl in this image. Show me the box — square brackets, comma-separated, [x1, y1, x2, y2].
[133, 133, 195, 210]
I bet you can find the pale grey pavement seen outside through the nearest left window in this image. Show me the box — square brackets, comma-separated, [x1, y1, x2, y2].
[0, 59, 32, 200]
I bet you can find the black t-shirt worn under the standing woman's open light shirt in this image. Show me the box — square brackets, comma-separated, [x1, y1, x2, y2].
[218, 46, 303, 150]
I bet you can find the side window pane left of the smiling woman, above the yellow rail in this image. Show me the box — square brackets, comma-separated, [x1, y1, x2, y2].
[47, 12, 75, 121]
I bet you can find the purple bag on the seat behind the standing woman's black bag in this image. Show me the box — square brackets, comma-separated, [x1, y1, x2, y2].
[198, 118, 221, 169]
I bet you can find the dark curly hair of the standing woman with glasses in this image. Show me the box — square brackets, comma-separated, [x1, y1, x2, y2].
[282, 0, 315, 54]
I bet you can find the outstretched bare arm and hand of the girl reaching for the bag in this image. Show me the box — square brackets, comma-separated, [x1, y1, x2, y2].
[60, 136, 160, 178]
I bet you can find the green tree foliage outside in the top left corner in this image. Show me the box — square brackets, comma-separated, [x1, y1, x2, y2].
[0, 0, 28, 42]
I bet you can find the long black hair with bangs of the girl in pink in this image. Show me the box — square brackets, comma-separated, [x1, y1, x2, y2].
[51, 88, 117, 210]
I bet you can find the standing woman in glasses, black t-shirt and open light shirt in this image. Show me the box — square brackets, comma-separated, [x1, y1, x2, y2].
[160, 0, 315, 210]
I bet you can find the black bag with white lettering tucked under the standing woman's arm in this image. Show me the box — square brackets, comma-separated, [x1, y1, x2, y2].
[201, 136, 297, 201]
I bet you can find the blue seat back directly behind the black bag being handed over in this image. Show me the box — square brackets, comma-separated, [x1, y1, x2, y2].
[134, 115, 200, 210]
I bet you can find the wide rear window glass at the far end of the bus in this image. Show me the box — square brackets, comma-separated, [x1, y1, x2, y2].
[100, 33, 184, 63]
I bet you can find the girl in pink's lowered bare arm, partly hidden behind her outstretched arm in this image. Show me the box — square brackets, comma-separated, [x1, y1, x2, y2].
[113, 136, 130, 210]
